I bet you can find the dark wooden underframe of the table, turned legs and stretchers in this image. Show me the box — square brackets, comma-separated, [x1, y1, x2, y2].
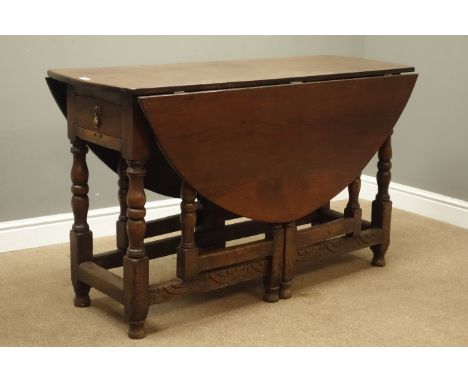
[70, 137, 392, 338]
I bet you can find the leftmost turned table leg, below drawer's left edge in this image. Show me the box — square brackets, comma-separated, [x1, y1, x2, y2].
[70, 138, 93, 307]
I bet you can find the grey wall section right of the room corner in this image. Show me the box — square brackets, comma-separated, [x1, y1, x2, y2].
[364, 36, 468, 200]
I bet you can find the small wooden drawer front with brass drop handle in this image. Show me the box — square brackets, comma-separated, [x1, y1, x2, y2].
[72, 94, 122, 150]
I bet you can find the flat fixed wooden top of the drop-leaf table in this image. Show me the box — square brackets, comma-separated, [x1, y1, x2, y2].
[47, 56, 414, 95]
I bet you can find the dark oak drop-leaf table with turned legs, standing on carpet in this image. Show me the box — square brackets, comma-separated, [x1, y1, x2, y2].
[46, 56, 417, 338]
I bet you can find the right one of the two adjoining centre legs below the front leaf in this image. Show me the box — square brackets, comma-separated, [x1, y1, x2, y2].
[279, 222, 297, 299]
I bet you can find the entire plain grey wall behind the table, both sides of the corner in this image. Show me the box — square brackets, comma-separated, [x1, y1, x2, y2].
[0, 36, 468, 221]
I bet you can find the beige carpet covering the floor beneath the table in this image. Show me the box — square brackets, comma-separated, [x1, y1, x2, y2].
[0, 203, 468, 346]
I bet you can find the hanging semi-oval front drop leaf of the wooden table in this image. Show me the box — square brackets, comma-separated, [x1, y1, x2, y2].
[139, 74, 417, 223]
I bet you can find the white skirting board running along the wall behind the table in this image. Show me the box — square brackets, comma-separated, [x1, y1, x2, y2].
[0, 175, 468, 252]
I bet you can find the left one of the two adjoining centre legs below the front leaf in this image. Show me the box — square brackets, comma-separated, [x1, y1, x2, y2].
[263, 224, 284, 302]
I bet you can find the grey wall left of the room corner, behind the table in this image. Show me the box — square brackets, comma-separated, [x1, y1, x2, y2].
[0, 36, 363, 221]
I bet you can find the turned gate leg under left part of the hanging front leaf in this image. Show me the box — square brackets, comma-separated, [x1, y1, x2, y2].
[177, 182, 198, 281]
